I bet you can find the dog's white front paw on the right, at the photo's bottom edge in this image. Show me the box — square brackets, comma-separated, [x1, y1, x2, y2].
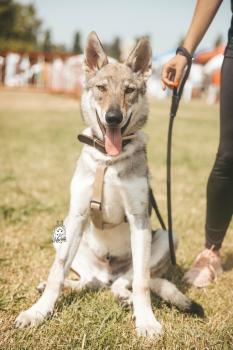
[136, 316, 163, 338]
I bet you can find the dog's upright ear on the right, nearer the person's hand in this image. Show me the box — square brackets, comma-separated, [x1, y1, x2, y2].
[126, 38, 152, 80]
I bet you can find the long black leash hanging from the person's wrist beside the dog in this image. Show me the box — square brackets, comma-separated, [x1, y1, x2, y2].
[167, 46, 192, 265]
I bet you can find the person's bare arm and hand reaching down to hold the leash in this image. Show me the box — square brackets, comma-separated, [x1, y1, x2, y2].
[162, 0, 222, 89]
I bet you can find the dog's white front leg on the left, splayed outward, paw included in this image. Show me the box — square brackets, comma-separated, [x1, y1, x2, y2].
[15, 164, 91, 328]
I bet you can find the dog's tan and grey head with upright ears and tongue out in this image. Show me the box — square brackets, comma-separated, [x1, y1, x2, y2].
[82, 32, 151, 155]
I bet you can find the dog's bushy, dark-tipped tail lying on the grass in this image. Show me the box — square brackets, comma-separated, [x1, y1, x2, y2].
[150, 278, 204, 317]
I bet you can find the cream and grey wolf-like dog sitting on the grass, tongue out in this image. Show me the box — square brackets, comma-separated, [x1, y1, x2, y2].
[15, 32, 203, 337]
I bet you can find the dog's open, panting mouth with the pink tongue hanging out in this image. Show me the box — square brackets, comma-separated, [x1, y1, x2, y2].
[96, 113, 132, 156]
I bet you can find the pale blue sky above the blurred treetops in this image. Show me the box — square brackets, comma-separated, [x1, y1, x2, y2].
[18, 0, 231, 55]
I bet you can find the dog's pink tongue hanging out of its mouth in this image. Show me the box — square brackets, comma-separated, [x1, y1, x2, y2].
[105, 127, 122, 156]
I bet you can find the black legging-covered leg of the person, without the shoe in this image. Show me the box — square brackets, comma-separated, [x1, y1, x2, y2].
[205, 52, 233, 250]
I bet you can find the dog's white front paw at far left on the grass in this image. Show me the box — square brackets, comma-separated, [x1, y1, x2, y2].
[15, 307, 46, 328]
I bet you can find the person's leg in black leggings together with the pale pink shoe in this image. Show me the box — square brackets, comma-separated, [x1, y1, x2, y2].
[184, 52, 233, 287]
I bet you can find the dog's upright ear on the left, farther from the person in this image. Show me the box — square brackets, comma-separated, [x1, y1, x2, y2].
[84, 32, 108, 76]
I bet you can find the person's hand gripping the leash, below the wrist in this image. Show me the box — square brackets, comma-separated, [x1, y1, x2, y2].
[161, 54, 187, 90]
